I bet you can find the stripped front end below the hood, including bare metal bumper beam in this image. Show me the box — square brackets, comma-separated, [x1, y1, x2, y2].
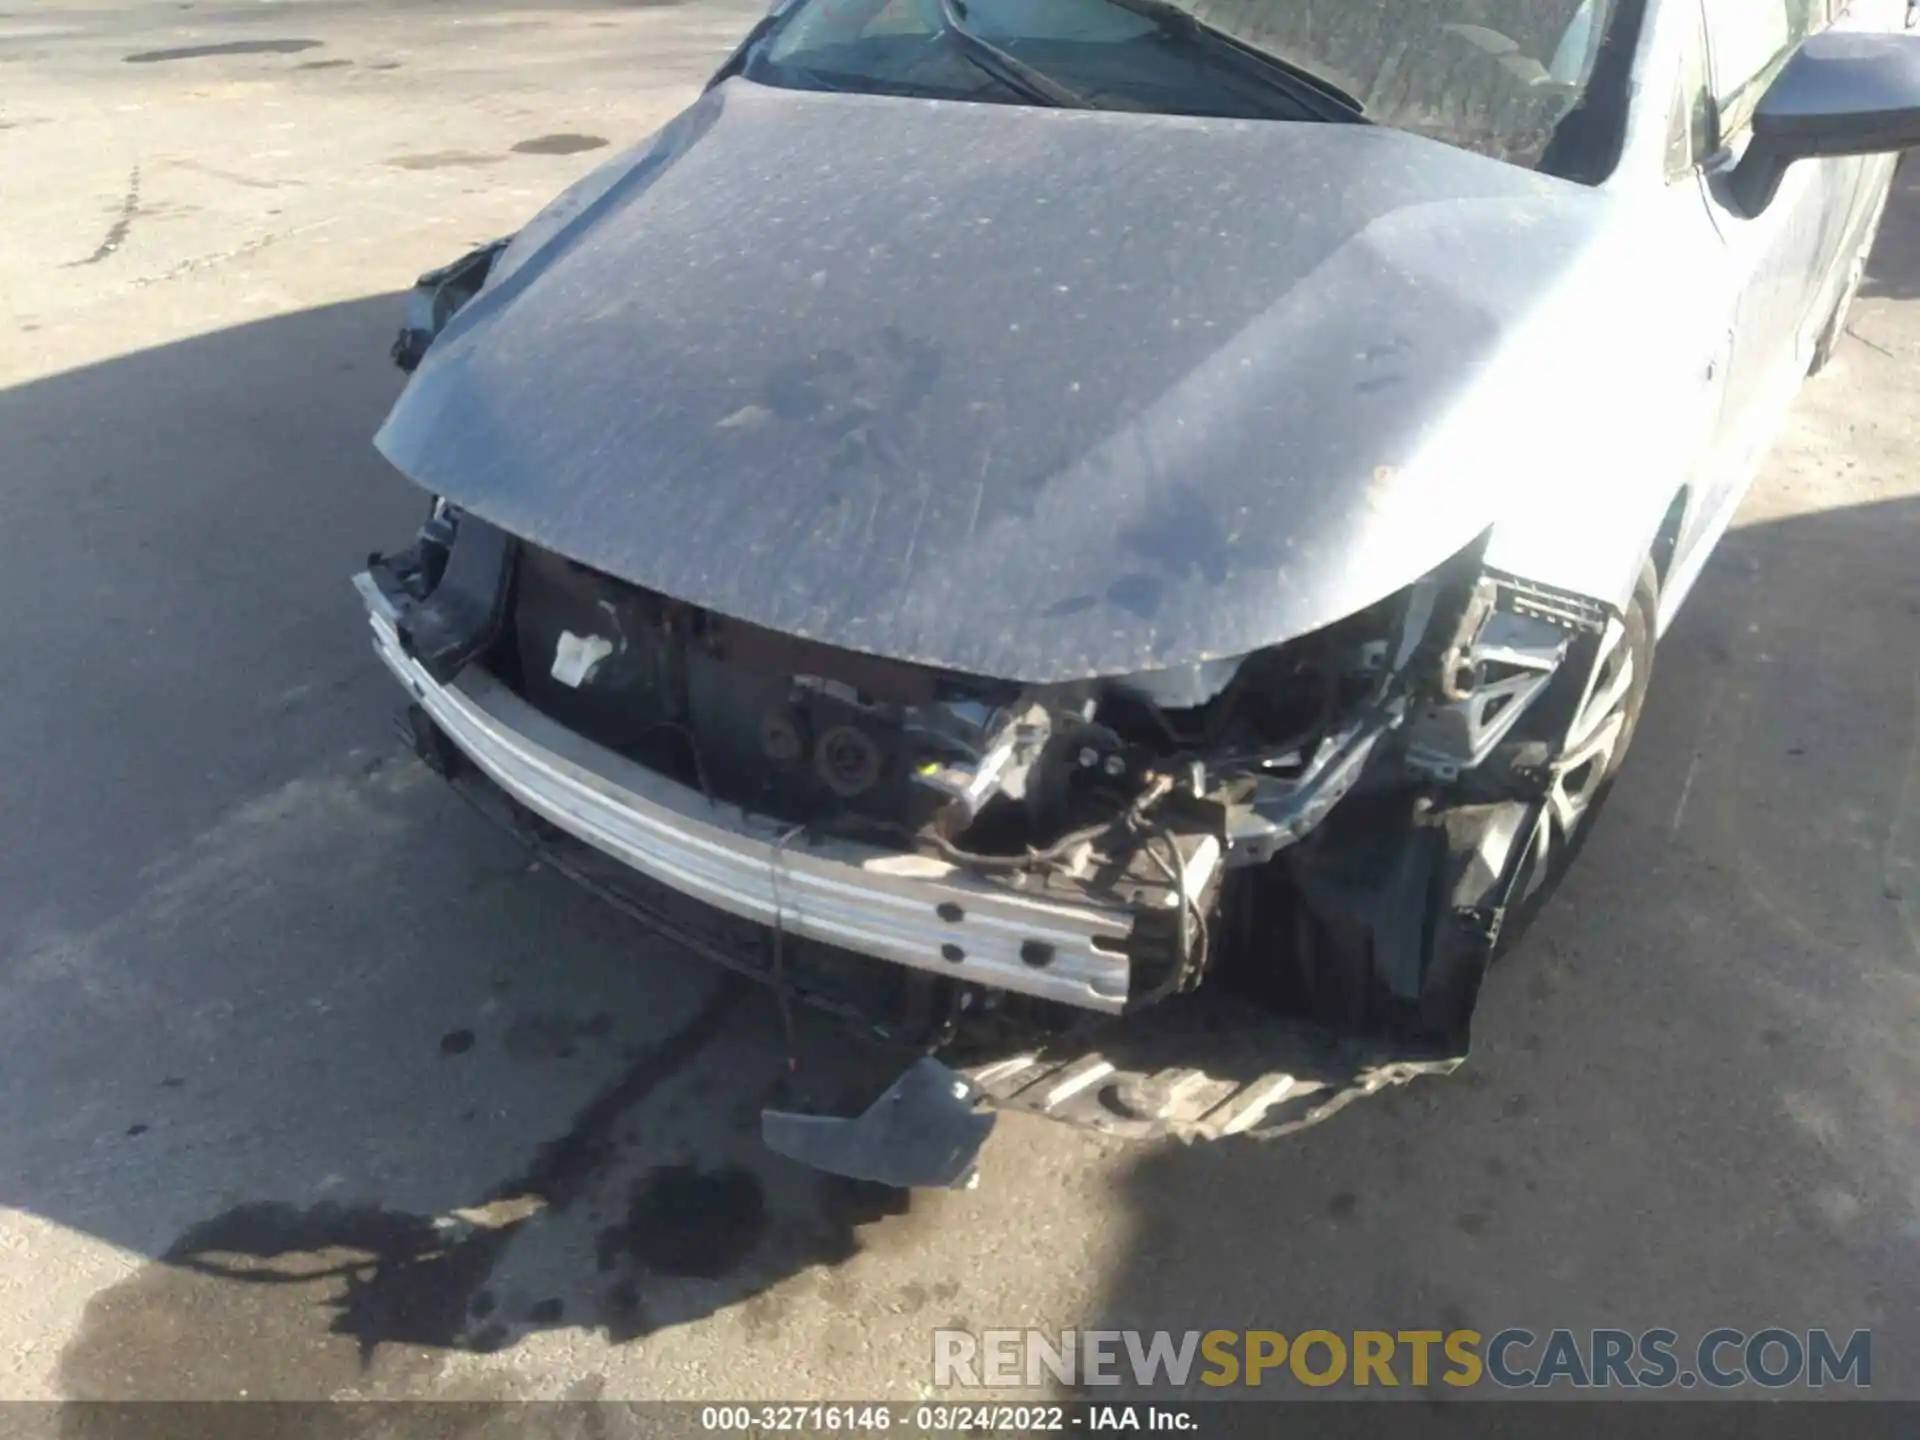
[357, 485, 1607, 1183]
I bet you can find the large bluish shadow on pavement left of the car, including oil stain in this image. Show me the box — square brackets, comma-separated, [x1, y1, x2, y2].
[0, 296, 937, 1398]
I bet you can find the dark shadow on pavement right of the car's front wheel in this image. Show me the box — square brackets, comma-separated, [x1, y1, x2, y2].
[1087, 487, 1920, 1394]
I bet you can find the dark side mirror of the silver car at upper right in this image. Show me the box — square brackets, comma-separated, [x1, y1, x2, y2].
[1728, 31, 1920, 215]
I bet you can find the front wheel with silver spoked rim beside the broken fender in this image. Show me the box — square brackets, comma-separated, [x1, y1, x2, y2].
[1500, 563, 1659, 950]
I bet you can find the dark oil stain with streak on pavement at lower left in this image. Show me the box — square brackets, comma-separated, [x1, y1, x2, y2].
[60, 979, 937, 1400]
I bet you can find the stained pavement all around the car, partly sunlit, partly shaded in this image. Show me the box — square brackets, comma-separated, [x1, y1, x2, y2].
[0, 0, 1920, 1398]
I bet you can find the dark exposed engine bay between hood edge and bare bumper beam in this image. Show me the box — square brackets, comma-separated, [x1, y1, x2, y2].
[371, 505, 1597, 1048]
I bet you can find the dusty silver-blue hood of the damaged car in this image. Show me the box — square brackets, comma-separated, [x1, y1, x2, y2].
[376, 81, 1607, 682]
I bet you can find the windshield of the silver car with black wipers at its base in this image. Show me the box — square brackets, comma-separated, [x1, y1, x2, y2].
[745, 0, 1644, 180]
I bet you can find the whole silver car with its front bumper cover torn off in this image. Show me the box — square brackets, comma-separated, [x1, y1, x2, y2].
[357, 0, 1920, 1183]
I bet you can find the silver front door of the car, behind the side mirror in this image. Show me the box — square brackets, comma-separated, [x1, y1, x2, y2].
[1695, 0, 1860, 503]
